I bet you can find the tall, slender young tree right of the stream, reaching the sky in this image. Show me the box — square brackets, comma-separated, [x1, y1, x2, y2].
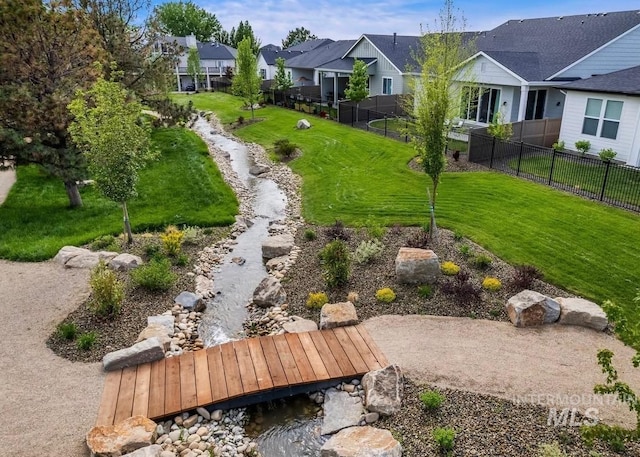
[407, 0, 473, 239]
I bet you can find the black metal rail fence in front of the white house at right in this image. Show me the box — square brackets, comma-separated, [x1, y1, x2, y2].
[469, 130, 640, 212]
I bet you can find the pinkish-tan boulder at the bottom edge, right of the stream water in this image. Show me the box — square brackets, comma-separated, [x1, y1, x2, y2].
[320, 425, 402, 457]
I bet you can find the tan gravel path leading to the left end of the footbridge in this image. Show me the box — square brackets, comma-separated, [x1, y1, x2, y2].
[0, 260, 104, 457]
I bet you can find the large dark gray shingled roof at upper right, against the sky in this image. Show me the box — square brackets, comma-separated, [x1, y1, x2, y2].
[476, 11, 640, 81]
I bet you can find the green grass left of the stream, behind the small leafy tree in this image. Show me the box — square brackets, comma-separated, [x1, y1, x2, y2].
[0, 129, 238, 261]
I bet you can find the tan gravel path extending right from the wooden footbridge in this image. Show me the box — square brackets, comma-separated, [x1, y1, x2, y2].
[364, 315, 640, 427]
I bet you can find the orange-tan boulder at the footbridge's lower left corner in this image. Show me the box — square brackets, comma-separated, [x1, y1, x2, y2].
[87, 416, 157, 457]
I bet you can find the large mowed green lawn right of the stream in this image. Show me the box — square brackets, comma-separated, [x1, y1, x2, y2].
[180, 94, 640, 321]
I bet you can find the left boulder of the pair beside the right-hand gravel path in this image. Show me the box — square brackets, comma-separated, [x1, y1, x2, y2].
[505, 290, 560, 327]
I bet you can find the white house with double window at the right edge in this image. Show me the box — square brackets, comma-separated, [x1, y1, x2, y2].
[560, 66, 640, 167]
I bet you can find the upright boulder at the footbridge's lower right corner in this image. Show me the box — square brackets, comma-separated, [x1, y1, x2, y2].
[362, 365, 404, 416]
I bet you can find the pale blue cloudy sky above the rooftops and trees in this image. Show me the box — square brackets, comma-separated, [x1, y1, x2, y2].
[148, 0, 640, 45]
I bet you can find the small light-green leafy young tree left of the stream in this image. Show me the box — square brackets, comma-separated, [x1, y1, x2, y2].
[69, 73, 155, 243]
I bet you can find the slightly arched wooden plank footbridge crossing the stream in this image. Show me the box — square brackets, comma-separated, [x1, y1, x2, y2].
[97, 325, 388, 425]
